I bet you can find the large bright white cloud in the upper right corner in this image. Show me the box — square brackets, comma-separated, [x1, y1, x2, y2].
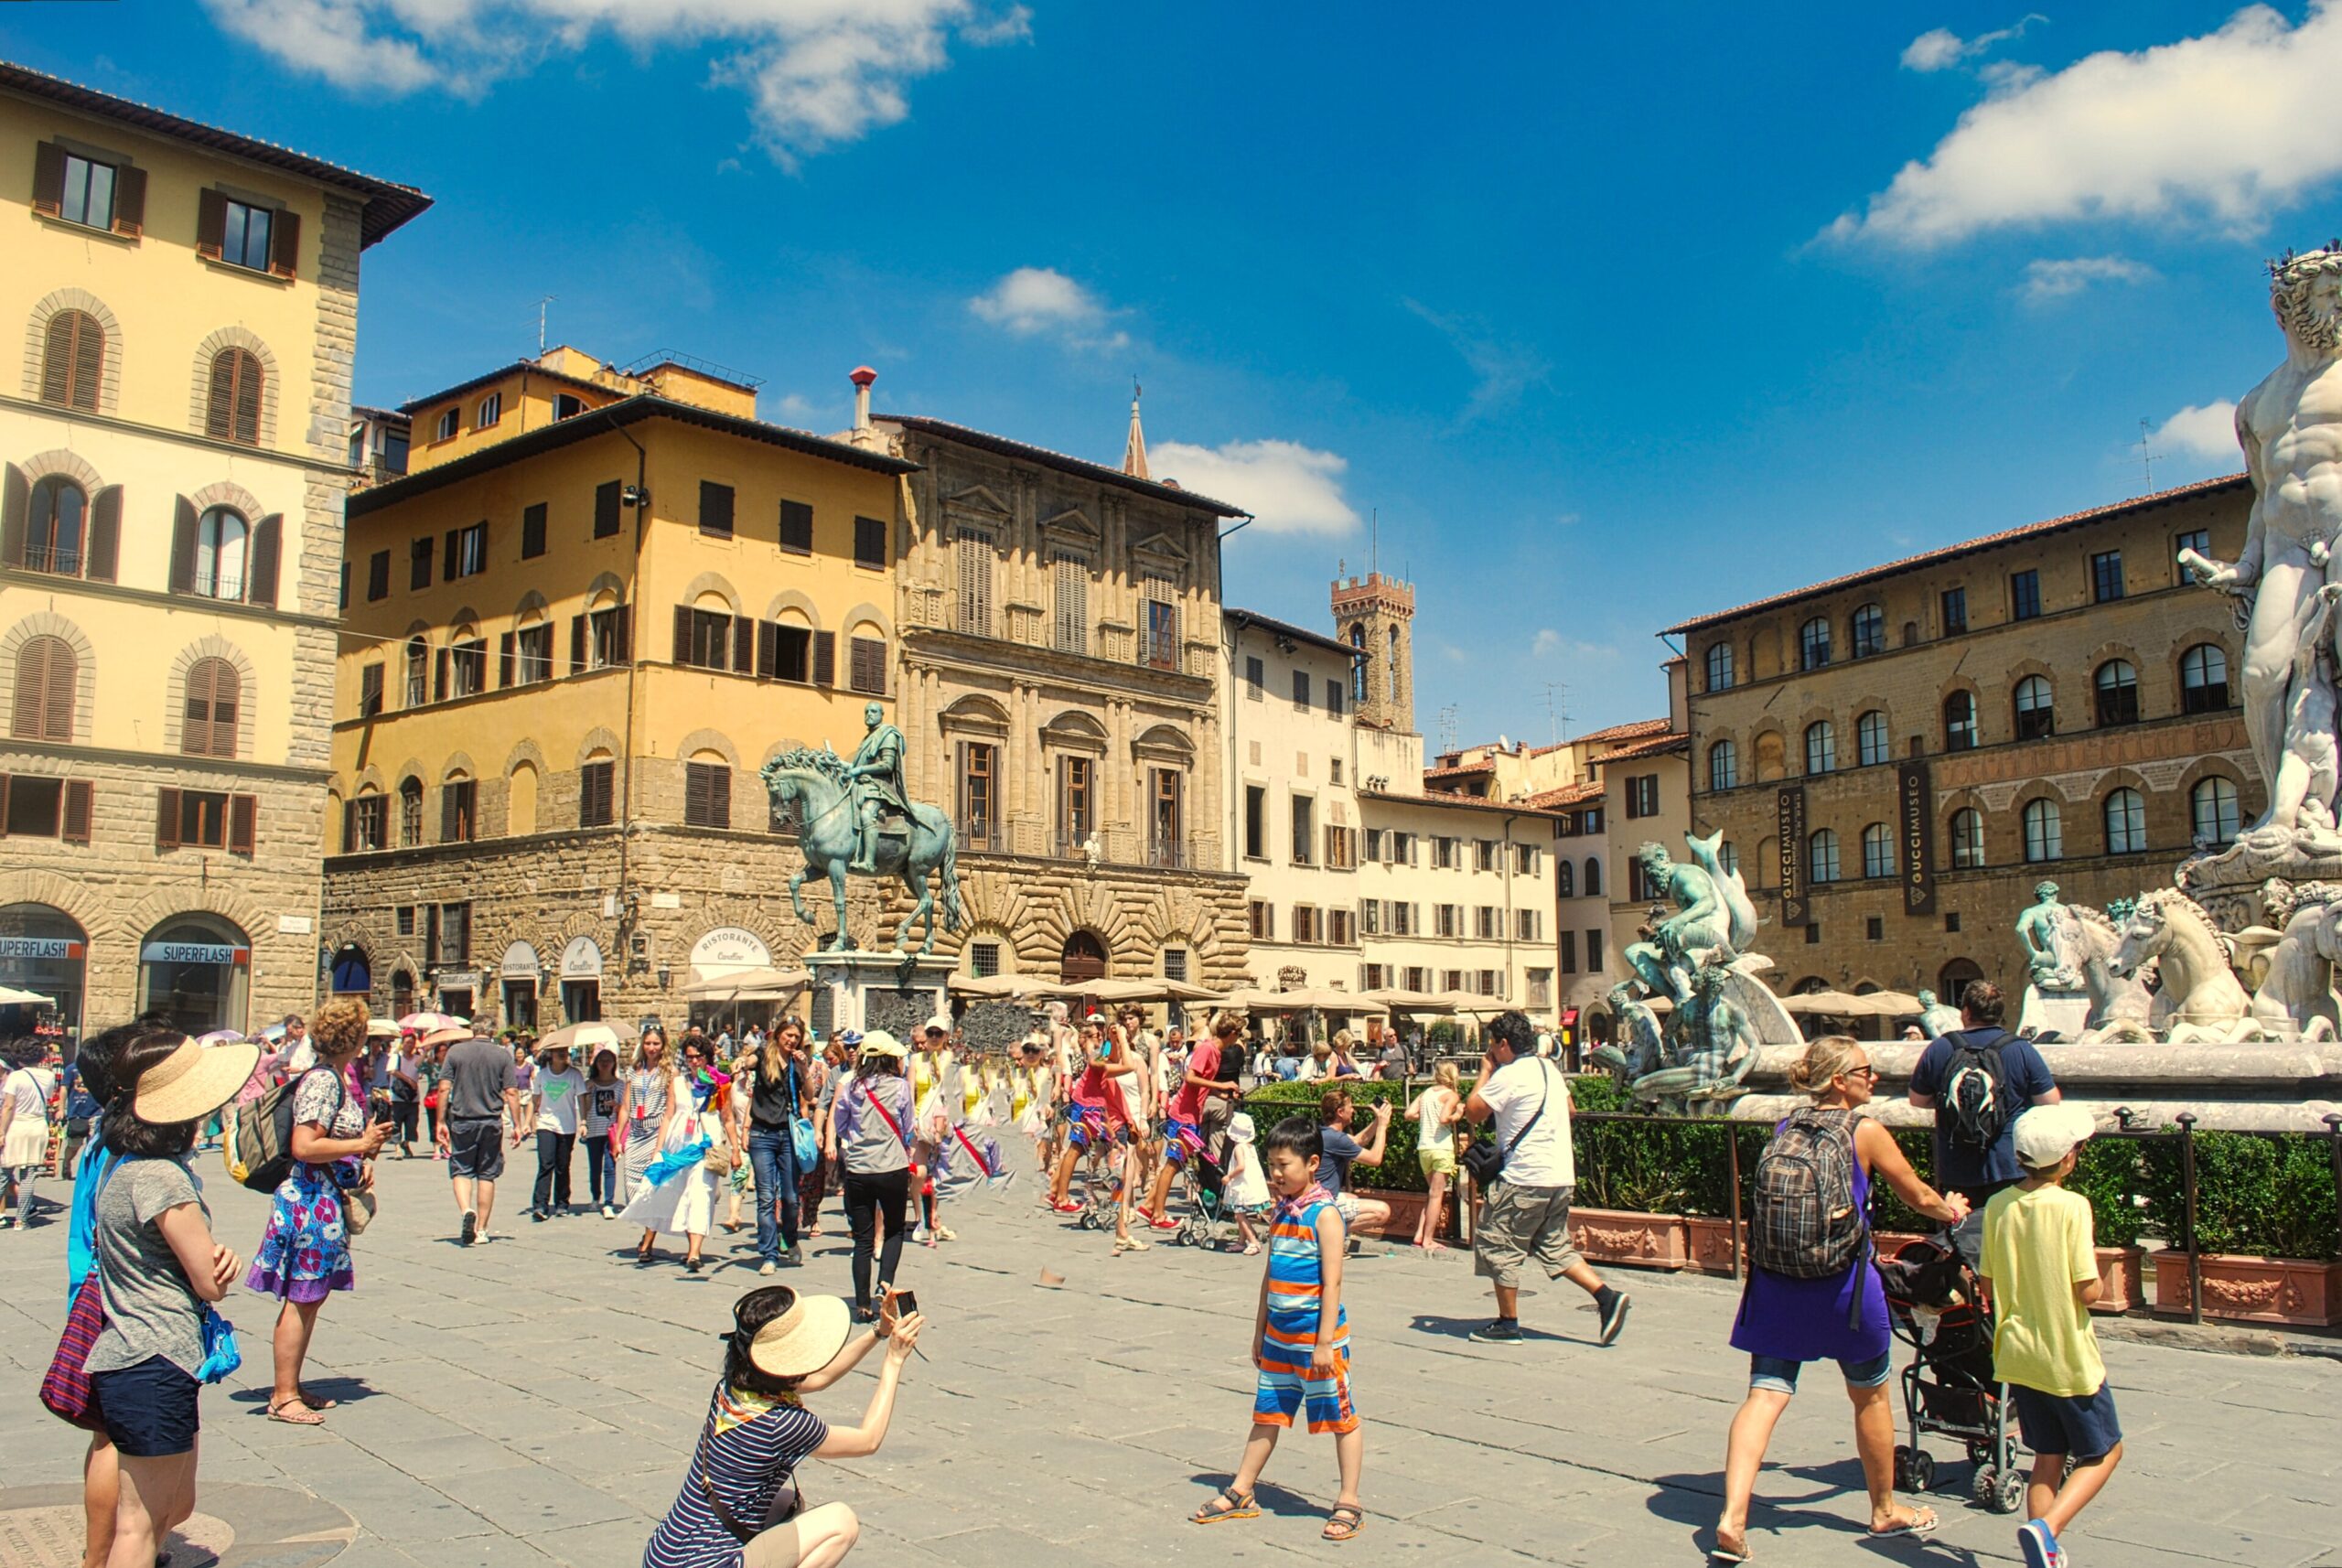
[1829, 0, 2342, 246]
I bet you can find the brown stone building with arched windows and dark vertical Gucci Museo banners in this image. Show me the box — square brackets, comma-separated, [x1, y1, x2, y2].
[1670, 478, 2265, 994]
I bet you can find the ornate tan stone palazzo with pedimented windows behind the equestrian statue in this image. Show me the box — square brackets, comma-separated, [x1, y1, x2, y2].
[876, 412, 1246, 985]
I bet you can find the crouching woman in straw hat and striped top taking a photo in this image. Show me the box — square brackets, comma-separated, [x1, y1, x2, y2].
[641, 1284, 923, 1568]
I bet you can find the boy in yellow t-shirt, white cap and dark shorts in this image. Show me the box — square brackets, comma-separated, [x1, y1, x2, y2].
[1982, 1104, 2122, 1568]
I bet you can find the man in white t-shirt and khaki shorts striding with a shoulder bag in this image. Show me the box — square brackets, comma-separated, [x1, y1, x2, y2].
[1464, 1011, 1630, 1346]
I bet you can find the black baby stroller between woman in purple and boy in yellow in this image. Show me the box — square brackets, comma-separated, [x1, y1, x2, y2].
[1878, 1236, 2025, 1514]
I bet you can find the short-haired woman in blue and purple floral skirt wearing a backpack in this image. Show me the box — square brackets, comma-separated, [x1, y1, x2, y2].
[243, 997, 392, 1428]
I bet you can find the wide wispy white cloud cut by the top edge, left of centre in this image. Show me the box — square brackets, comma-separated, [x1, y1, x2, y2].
[204, 0, 1030, 166]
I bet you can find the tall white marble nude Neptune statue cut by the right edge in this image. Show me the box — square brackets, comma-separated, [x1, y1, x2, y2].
[2180, 241, 2342, 847]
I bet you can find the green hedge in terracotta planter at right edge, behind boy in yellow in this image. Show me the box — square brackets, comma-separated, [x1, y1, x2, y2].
[2144, 1133, 2342, 1327]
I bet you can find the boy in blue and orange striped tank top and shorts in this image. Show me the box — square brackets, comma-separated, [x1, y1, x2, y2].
[1192, 1116, 1365, 1540]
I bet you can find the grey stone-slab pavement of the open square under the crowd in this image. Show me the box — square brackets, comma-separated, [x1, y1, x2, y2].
[0, 1156, 2342, 1568]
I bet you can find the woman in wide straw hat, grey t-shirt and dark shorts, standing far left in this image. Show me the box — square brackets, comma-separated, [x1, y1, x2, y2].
[84, 1020, 260, 1563]
